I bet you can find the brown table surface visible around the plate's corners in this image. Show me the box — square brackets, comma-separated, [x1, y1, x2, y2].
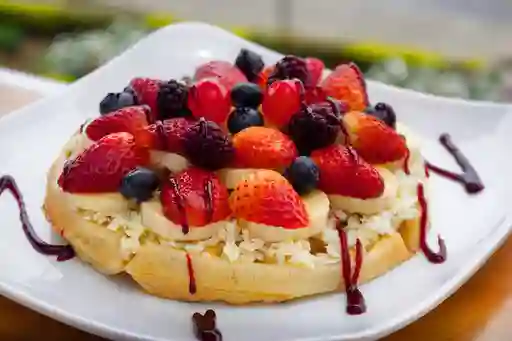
[0, 85, 512, 341]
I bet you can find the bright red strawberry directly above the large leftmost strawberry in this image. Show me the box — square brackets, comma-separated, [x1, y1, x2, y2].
[85, 106, 151, 147]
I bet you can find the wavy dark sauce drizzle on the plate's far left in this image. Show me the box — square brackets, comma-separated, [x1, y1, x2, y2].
[0, 175, 75, 262]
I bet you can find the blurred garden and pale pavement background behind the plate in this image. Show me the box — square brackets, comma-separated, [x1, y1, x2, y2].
[0, 0, 512, 101]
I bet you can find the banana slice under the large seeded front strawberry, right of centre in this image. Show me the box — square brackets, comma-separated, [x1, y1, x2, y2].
[239, 190, 329, 242]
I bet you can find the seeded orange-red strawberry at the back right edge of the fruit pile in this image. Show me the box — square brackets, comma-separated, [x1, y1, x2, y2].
[320, 63, 369, 111]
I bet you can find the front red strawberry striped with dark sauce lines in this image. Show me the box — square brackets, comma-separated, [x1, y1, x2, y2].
[160, 167, 231, 226]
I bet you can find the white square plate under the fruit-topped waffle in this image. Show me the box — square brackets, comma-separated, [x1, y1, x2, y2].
[0, 24, 512, 341]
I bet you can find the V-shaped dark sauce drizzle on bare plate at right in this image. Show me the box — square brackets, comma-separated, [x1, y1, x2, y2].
[426, 134, 485, 194]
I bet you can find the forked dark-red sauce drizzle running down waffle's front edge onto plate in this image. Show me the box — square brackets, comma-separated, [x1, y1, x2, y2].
[336, 223, 366, 315]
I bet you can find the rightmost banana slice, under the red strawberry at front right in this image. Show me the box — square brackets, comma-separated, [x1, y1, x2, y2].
[329, 167, 398, 215]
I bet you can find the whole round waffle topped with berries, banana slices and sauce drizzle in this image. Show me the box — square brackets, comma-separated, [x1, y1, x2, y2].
[44, 49, 445, 313]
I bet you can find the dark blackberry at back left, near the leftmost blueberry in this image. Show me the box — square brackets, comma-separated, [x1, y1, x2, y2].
[157, 79, 191, 120]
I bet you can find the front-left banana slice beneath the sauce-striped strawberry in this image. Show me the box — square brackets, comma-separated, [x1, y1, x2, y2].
[141, 200, 230, 241]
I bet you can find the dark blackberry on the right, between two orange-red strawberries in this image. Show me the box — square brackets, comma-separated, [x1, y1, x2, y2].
[288, 101, 341, 154]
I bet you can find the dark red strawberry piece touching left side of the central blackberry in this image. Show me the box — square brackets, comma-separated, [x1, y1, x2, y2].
[147, 117, 194, 154]
